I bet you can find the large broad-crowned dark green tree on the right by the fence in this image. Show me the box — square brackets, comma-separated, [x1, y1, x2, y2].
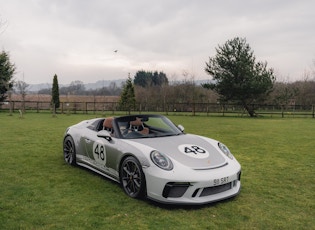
[203, 37, 276, 117]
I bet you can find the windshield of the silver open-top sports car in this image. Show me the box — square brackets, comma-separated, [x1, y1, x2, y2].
[115, 115, 182, 139]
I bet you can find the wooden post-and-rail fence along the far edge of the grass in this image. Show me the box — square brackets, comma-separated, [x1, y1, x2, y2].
[0, 101, 315, 118]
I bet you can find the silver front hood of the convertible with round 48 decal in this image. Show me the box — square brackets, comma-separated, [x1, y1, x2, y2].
[126, 134, 227, 169]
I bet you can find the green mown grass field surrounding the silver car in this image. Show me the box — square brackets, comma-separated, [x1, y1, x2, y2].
[0, 113, 315, 229]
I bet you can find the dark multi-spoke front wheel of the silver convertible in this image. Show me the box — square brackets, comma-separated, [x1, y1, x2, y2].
[120, 156, 146, 198]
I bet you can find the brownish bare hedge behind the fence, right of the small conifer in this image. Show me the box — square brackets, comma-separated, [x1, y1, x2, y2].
[115, 70, 315, 113]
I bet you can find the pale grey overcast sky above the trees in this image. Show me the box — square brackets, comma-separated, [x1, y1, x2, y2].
[0, 0, 315, 84]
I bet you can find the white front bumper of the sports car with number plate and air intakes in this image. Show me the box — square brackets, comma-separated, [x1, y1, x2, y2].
[144, 165, 241, 204]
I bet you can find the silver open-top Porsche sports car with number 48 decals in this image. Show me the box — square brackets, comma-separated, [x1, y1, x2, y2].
[63, 115, 241, 205]
